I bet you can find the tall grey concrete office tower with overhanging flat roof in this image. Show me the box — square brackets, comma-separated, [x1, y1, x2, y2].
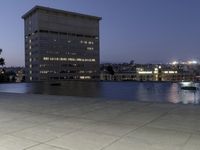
[22, 6, 101, 81]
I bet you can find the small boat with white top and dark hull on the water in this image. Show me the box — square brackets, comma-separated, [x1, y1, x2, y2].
[180, 81, 199, 91]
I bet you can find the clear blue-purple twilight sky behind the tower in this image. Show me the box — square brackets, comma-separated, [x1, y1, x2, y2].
[0, 0, 200, 66]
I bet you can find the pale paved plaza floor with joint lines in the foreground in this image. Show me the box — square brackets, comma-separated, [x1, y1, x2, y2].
[0, 93, 200, 150]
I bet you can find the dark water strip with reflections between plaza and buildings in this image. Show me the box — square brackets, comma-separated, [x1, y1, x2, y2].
[0, 81, 200, 104]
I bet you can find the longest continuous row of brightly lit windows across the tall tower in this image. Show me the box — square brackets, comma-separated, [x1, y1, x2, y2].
[43, 57, 96, 62]
